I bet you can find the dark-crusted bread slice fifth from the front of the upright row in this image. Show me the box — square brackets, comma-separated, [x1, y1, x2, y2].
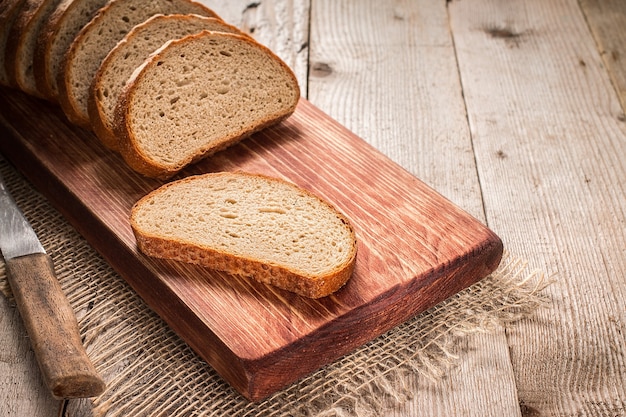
[5, 0, 60, 97]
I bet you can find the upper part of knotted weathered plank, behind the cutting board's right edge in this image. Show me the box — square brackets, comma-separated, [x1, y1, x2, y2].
[309, 1, 483, 214]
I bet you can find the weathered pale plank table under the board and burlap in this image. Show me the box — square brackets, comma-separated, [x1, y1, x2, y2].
[0, 0, 626, 416]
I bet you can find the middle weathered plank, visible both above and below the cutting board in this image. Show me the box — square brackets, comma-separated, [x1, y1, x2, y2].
[309, 0, 519, 416]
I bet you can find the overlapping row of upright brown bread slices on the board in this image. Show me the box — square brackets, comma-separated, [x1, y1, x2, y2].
[0, 0, 300, 179]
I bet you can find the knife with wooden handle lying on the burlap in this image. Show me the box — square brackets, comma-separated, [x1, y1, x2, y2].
[0, 171, 105, 399]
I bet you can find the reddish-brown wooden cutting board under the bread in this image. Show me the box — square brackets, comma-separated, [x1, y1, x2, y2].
[0, 90, 502, 400]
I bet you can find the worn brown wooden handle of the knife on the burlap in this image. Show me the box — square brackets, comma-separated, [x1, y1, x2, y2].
[6, 253, 105, 399]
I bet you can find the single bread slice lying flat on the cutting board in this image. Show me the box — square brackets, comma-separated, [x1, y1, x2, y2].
[130, 172, 357, 298]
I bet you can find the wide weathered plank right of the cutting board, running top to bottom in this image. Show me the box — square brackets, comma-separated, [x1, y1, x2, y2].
[450, 0, 626, 416]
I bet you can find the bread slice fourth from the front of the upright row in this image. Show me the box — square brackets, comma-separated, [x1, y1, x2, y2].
[33, 0, 108, 101]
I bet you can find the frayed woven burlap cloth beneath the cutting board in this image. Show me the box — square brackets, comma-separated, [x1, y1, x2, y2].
[0, 157, 548, 417]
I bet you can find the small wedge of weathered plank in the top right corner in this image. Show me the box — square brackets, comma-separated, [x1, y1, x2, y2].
[580, 0, 626, 117]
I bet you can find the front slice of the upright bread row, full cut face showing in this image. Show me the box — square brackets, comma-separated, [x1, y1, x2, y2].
[114, 31, 300, 179]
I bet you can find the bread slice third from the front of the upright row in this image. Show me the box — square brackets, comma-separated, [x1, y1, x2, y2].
[57, 0, 217, 129]
